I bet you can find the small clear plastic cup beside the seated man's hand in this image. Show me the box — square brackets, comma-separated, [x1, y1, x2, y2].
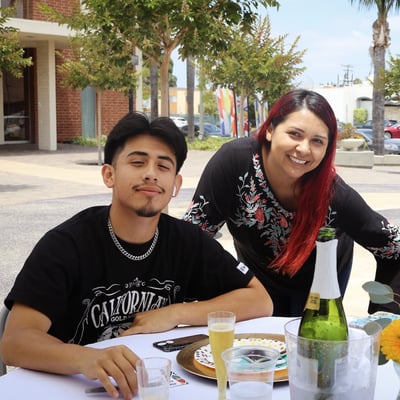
[136, 357, 171, 400]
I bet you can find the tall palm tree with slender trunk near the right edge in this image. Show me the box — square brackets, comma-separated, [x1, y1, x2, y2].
[350, 0, 400, 155]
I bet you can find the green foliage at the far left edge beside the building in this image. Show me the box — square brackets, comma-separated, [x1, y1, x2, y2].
[0, 7, 32, 78]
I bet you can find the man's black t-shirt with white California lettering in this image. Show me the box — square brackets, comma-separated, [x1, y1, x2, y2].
[5, 206, 253, 344]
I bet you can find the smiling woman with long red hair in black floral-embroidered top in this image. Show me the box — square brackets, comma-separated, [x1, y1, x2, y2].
[184, 89, 400, 316]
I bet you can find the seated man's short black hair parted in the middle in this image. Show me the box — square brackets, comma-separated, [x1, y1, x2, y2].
[104, 112, 187, 173]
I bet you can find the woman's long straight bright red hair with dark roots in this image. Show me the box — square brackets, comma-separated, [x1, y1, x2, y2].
[257, 89, 337, 276]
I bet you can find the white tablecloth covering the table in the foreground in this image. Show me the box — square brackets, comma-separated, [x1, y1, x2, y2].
[0, 317, 399, 400]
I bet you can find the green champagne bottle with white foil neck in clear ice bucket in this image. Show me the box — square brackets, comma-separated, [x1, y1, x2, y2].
[298, 227, 348, 389]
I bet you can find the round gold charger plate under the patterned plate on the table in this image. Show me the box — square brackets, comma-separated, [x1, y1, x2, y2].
[176, 333, 289, 382]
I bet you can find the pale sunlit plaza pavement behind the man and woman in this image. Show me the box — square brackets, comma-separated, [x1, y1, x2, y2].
[0, 144, 400, 315]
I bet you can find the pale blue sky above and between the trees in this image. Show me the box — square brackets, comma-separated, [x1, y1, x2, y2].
[173, 0, 400, 88]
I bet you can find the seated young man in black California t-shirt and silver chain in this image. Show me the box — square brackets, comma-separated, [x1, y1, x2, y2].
[0, 113, 272, 399]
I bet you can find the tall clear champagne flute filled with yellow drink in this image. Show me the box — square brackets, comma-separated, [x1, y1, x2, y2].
[208, 311, 236, 400]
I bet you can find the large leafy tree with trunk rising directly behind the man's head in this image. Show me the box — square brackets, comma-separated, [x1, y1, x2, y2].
[40, 0, 279, 116]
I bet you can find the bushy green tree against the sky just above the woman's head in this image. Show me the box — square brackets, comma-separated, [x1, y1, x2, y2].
[200, 18, 305, 131]
